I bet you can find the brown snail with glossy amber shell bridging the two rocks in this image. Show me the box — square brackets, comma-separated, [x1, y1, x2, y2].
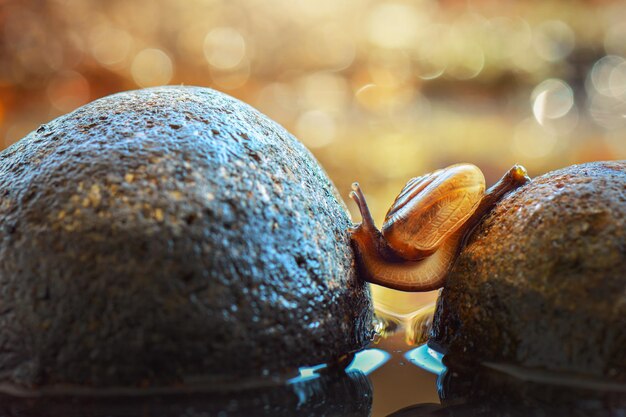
[350, 164, 530, 291]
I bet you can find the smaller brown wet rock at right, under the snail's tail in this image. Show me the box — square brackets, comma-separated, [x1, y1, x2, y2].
[430, 161, 626, 380]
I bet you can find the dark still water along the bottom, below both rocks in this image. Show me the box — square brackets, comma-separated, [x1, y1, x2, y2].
[0, 337, 626, 417]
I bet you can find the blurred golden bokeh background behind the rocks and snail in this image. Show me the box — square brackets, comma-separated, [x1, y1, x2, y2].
[0, 0, 626, 407]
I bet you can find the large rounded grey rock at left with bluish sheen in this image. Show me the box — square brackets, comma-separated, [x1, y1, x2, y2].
[0, 87, 372, 386]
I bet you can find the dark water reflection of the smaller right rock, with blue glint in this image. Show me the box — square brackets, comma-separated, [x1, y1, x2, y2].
[391, 345, 626, 417]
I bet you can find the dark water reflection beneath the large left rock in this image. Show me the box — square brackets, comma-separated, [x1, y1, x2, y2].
[0, 371, 372, 417]
